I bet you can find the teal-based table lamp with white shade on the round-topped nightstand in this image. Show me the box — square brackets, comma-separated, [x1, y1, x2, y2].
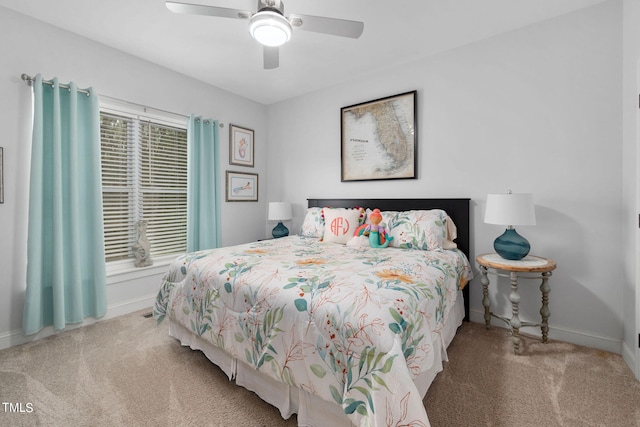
[484, 191, 536, 260]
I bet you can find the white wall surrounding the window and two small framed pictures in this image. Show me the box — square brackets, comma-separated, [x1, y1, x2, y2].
[0, 7, 267, 348]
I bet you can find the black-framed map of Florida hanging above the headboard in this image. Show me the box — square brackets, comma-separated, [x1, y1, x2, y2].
[340, 90, 418, 181]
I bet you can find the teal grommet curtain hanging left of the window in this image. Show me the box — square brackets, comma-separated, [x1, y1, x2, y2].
[23, 75, 107, 335]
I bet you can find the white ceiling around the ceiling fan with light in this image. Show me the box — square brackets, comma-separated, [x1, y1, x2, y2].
[0, 0, 605, 104]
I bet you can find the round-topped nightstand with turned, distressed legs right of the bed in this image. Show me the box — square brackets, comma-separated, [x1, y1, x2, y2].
[476, 254, 556, 354]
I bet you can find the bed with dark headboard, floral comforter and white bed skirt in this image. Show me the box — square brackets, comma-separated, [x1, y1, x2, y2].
[153, 199, 471, 426]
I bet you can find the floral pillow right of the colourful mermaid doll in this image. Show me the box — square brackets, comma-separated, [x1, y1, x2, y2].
[367, 209, 453, 251]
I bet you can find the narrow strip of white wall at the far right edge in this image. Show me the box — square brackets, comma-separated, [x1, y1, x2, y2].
[621, 0, 640, 379]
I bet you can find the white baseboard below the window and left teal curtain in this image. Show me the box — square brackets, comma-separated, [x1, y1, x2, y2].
[0, 295, 156, 350]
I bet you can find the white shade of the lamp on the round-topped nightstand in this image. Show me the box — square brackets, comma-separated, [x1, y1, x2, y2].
[484, 193, 536, 225]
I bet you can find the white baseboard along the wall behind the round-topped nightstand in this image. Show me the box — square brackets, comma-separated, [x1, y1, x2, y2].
[470, 309, 622, 355]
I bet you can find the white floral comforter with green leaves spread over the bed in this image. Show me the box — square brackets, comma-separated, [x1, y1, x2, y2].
[154, 236, 471, 426]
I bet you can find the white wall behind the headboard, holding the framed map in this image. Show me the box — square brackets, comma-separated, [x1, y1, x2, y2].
[268, 1, 623, 353]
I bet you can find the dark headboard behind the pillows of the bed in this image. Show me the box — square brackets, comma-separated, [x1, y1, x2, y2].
[307, 199, 471, 321]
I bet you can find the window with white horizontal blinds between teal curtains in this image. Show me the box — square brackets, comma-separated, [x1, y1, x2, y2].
[100, 102, 187, 262]
